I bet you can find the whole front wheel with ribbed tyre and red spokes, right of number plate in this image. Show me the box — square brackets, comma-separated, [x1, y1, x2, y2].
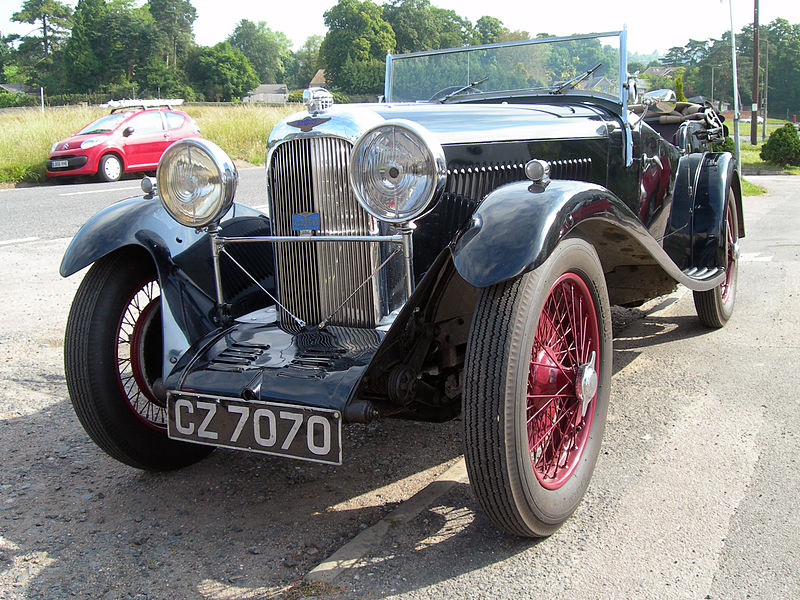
[464, 239, 612, 537]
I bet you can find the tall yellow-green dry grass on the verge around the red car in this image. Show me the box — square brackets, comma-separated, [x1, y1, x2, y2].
[0, 105, 299, 183]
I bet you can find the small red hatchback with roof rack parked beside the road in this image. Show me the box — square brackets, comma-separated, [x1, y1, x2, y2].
[47, 102, 200, 181]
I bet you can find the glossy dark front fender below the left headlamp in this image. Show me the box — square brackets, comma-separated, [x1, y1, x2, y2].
[60, 198, 271, 377]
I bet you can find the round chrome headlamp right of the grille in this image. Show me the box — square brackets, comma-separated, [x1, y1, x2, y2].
[349, 120, 447, 223]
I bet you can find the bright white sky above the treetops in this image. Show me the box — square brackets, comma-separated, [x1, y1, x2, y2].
[0, 0, 800, 55]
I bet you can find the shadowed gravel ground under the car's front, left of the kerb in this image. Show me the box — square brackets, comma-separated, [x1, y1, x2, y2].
[0, 392, 461, 599]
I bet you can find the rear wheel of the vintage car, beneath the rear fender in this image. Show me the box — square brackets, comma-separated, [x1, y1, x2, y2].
[694, 191, 739, 329]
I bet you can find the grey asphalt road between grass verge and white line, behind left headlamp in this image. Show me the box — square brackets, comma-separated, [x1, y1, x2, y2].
[0, 167, 267, 244]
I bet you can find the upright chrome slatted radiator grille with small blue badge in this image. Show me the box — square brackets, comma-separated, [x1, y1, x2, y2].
[269, 137, 381, 328]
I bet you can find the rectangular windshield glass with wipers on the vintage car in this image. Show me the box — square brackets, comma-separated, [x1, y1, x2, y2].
[386, 32, 625, 102]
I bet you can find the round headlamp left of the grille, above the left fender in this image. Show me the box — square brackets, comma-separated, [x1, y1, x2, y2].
[156, 138, 239, 227]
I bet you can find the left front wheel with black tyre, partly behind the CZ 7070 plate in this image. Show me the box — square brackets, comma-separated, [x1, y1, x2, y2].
[64, 252, 213, 470]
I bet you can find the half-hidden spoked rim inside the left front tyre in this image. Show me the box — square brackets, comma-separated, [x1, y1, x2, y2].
[115, 281, 167, 431]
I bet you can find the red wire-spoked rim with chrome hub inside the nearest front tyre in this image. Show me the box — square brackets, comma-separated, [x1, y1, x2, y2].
[526, 273, 600, 490]
